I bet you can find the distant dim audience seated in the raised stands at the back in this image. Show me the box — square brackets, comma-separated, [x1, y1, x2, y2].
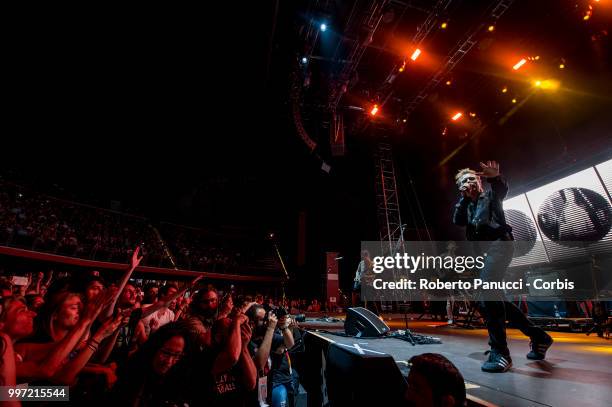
[0, 180, 275, 273]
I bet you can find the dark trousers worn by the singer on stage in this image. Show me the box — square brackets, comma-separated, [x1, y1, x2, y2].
[479, 239, 548, 356]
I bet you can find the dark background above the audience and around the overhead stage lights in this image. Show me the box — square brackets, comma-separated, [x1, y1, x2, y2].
[0, 0, 612, 294]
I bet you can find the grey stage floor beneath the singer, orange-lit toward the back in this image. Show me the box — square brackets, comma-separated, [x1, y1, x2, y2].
[300, 316, 612, 406]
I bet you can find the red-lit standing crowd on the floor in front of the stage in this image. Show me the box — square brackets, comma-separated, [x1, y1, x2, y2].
[0, 248, 465, 407]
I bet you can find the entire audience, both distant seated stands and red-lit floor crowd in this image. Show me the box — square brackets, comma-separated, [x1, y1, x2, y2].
[0, 185, 465, 407]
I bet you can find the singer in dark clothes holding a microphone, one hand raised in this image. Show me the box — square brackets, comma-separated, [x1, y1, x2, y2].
[453, 161, 553, 372]
